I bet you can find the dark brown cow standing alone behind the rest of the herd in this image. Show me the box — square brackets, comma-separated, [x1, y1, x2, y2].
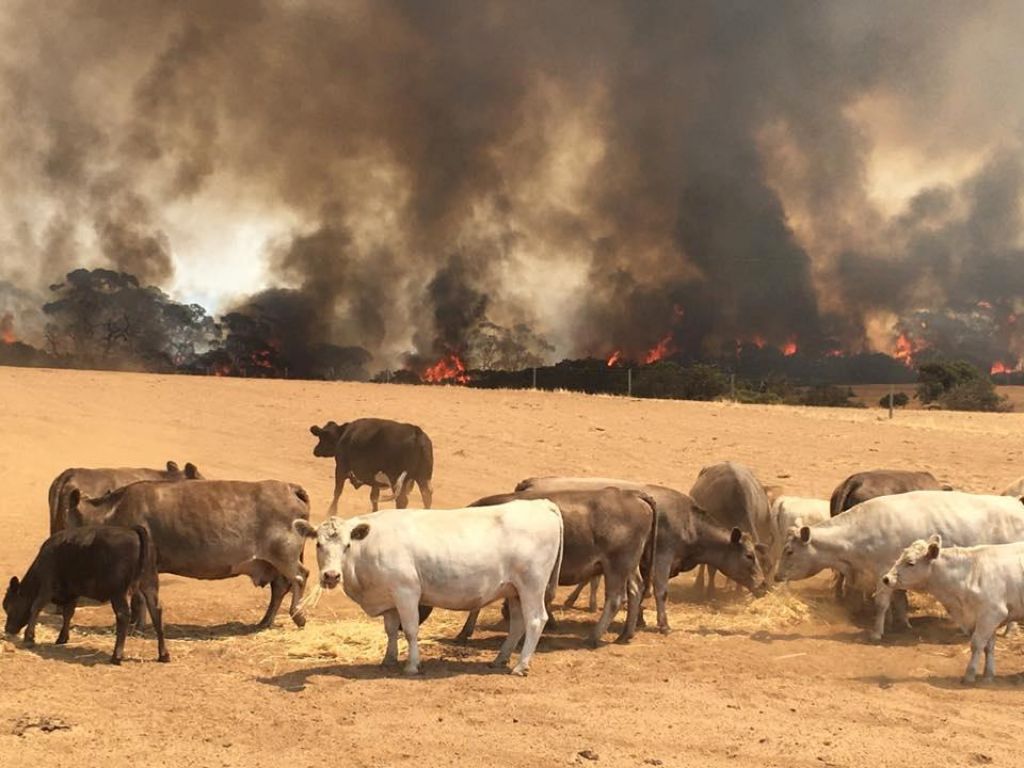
[309, 419, 434, 516]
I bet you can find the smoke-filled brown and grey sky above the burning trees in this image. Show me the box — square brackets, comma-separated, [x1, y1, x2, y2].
[0, 0, 1024, 366]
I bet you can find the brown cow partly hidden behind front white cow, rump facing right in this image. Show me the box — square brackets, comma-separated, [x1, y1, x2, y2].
[458, 487, 657, 647]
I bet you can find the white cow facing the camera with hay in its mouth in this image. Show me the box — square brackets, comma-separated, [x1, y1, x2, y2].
[295, 499, 562, 675]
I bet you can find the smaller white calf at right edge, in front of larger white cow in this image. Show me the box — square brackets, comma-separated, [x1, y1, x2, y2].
[882, 535, 1024, 683]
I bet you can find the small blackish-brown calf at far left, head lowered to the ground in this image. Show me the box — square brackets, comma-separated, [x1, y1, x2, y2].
[3, 525, 171, 664]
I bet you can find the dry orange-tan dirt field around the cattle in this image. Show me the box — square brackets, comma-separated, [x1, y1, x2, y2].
[0, 369, 1024, 768]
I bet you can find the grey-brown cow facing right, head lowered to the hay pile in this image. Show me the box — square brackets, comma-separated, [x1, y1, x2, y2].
[516, 477, 765, 634]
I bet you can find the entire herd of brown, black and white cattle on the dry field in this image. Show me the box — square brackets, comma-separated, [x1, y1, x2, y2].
[3, 419, 1024, 682]
